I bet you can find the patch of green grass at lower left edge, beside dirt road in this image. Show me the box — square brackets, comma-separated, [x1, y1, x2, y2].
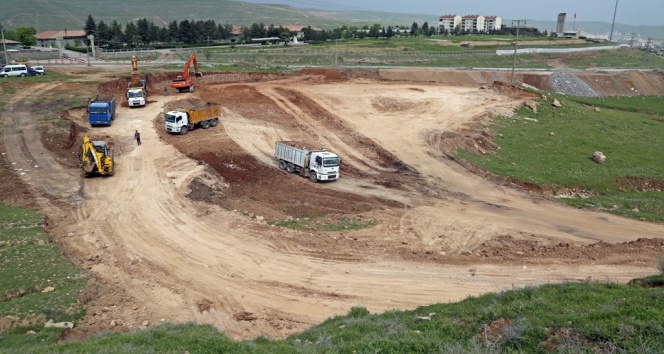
[0, 204, 88, 352]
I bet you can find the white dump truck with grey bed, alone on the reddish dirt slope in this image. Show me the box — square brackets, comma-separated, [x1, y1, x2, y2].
[274, 141, 341, 182]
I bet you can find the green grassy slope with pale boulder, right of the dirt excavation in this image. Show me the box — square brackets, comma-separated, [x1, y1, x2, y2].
[459, 96, 664, 222]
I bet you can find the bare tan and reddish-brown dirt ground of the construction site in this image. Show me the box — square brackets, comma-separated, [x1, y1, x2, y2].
[0, 68, 664, 339]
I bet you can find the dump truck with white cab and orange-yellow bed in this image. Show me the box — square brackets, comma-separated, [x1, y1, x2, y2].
[164, 102, 221, 135]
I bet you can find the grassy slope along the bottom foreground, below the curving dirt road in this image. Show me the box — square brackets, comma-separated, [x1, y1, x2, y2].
[10, 282, 664, 353]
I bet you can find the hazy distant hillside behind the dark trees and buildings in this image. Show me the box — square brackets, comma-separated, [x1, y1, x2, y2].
[0, 0, 664, 39]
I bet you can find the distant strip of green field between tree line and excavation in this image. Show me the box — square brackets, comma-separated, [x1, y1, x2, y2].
[170, 36, 664, 70]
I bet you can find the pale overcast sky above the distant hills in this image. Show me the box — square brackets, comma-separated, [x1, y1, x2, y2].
[242, 0, 664, 26]
